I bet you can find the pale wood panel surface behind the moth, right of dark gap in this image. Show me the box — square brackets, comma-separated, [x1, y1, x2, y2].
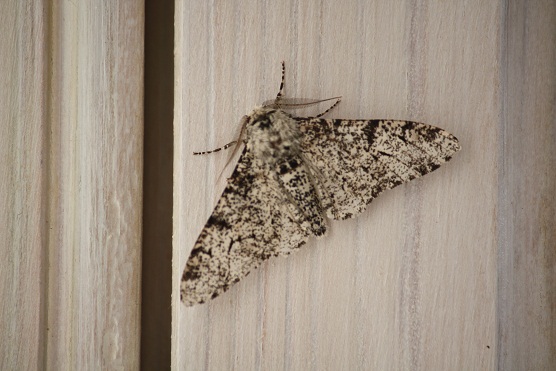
[172, 0, 556, 370]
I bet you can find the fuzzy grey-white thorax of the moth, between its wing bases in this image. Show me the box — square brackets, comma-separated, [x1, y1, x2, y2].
[246, 107, 302, 163]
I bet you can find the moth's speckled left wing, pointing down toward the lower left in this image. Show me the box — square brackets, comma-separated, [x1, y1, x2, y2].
[181, 148, 309, 306]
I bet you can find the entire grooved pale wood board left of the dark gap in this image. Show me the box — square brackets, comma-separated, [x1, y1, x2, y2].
[0, 1, 143, 370]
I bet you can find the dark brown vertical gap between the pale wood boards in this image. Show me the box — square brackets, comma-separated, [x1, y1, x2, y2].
[141, 0, 174, 370]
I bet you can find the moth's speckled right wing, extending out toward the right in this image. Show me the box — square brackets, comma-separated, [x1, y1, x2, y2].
[298, 118, 460, 219]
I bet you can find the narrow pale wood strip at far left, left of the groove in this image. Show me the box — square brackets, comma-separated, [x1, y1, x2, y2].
[0, 1, 48, 370]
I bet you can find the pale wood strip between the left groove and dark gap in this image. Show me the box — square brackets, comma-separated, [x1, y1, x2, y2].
[47, 1, 143, 369]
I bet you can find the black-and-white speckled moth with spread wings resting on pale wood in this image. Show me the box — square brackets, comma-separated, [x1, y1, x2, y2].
[180, 62, 460, 306]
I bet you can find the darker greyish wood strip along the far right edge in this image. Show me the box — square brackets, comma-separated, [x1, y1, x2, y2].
[497, 1, 556, 370]
